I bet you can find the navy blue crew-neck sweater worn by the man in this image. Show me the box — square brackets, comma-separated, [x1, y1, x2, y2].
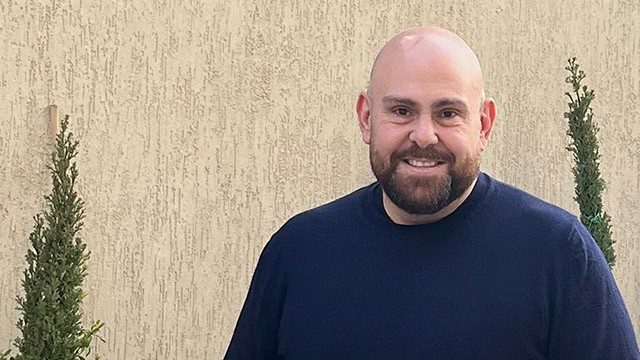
[225, 174, 639, 360]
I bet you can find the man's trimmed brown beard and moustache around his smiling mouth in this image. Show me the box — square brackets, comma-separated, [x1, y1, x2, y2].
[369, 144, 480, 215]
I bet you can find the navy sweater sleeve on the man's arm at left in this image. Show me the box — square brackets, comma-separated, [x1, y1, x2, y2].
[225, 238, 286, 360]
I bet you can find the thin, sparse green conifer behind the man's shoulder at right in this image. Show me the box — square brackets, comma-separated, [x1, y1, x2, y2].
[564, 57, 616, 266]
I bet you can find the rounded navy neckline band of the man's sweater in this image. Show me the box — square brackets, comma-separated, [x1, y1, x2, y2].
[361, 173, 492, 238]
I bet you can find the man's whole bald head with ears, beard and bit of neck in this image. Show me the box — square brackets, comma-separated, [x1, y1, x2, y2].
[356, 27, 496, 224]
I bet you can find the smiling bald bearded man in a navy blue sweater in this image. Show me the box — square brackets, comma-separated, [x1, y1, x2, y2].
[226, 28, 639, 359]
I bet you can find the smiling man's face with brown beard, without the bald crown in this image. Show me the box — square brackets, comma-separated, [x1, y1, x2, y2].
[358, 38, 490, 215]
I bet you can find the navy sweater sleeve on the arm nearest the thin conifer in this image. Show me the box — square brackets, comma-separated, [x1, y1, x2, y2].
[548, 225, 640, 360]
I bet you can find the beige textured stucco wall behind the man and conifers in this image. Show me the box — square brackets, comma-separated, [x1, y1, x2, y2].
[0, 0, 640, 359]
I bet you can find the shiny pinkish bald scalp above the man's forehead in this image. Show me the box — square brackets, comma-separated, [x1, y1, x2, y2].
[367, 27, 484, 102]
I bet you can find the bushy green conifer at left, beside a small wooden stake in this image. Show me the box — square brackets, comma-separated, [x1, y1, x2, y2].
[0, 116, 104, 360]
